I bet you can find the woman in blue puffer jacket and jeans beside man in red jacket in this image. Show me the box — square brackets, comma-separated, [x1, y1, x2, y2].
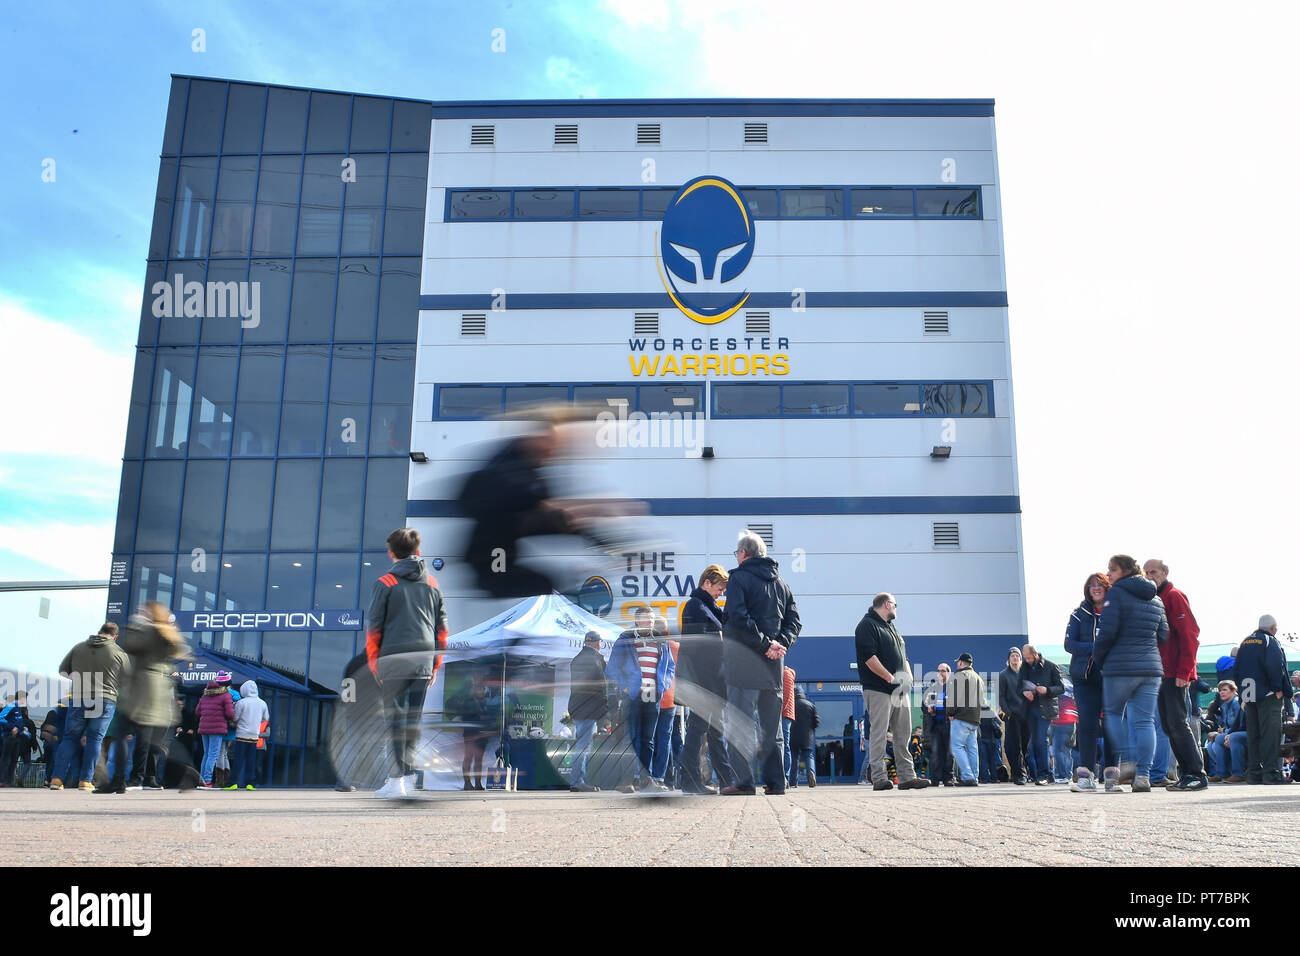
[1092, 554, 1169, 793]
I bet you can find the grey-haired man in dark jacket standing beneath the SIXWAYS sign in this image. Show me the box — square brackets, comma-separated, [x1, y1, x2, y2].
[722, 529, 802, 796]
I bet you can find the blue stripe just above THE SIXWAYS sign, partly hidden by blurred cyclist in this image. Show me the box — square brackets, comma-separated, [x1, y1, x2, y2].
[407, 494, 1021, 518]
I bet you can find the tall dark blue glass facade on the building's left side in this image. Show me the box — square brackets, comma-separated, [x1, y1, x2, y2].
[109, 77, 432, 784]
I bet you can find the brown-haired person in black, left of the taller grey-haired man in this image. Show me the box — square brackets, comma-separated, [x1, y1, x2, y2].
[673, 564, 736, 793]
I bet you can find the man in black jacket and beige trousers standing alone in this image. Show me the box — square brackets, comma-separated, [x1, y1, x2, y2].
[853, 592, 930, 790]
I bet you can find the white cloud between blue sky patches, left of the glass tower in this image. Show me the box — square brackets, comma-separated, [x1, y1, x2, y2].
[0, 291, 139, 460]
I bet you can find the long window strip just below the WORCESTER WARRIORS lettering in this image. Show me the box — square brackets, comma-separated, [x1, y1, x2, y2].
[433, 381, 993, 419]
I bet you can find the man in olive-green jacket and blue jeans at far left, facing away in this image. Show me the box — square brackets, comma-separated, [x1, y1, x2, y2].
[49, 620, 129, 791]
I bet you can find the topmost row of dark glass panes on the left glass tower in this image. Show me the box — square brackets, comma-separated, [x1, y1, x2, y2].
[163, 77, 433, 156]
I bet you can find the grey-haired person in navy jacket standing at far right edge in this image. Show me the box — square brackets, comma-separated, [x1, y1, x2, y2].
[1236, 614, 1292, 783]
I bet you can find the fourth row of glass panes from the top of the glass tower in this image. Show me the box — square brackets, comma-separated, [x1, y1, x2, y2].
[125, 345, 415, 459]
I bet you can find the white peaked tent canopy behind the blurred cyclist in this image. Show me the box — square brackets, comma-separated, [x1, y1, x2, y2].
[443, 593, 623, 663]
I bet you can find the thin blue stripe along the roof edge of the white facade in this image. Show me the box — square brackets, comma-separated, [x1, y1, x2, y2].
[433, 99, 993, 120]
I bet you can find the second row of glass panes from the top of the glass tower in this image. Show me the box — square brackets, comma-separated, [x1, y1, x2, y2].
[150, 152, 428, 259]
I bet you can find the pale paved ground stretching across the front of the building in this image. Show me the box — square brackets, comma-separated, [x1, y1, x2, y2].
[0, 784, 1300, 866]
